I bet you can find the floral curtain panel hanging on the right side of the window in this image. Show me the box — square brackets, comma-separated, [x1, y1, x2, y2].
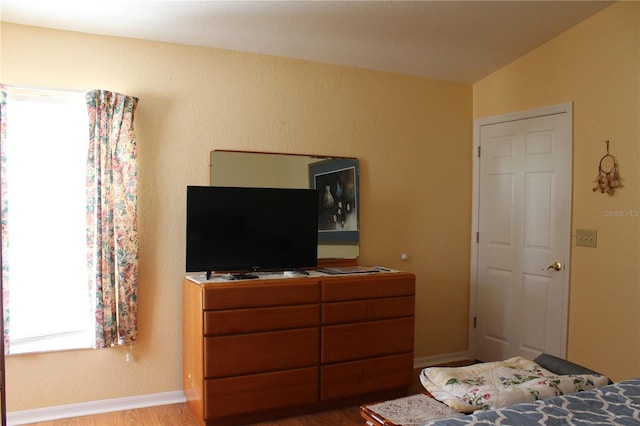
[87, 90, 138, 348]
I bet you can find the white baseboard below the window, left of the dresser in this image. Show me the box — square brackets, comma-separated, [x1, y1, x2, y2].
[7, 391, 187, 425]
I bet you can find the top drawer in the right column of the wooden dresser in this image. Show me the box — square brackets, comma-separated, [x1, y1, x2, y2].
[321, 273, 415, 302]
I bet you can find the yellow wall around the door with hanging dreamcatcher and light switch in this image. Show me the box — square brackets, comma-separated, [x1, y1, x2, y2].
[473, 2, 640, 380]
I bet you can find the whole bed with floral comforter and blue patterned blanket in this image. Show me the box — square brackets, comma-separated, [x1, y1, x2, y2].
[361, 354, 640, 426]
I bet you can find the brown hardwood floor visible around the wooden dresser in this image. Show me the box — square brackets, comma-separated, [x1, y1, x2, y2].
[26, 361, 473, 426]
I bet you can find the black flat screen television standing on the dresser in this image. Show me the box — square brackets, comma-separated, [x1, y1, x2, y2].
[186, 186, 318, 274]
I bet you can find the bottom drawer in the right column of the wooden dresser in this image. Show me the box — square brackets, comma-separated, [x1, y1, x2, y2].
[320, 353, 413, 401]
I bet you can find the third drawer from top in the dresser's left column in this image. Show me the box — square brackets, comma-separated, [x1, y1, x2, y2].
[204, 327, 320, 378]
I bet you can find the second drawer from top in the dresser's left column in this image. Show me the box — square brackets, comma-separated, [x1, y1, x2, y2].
[204, 304, 320, 336]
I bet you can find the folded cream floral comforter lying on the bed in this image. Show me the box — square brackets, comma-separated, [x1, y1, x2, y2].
[420, 357, 609, 413]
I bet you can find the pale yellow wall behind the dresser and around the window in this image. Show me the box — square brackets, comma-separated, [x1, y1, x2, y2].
[0, 24, 472, 411]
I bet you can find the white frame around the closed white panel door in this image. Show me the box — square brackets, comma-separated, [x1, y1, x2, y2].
[468, 102, 573, 358]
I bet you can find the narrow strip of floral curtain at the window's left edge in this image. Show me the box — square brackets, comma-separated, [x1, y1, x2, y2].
[0, 84, 9, 354]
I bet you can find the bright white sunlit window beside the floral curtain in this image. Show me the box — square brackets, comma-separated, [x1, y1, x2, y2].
[3, 88, 94, 354]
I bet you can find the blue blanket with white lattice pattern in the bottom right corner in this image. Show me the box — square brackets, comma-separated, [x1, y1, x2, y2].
[427, 378, 640, 426]
